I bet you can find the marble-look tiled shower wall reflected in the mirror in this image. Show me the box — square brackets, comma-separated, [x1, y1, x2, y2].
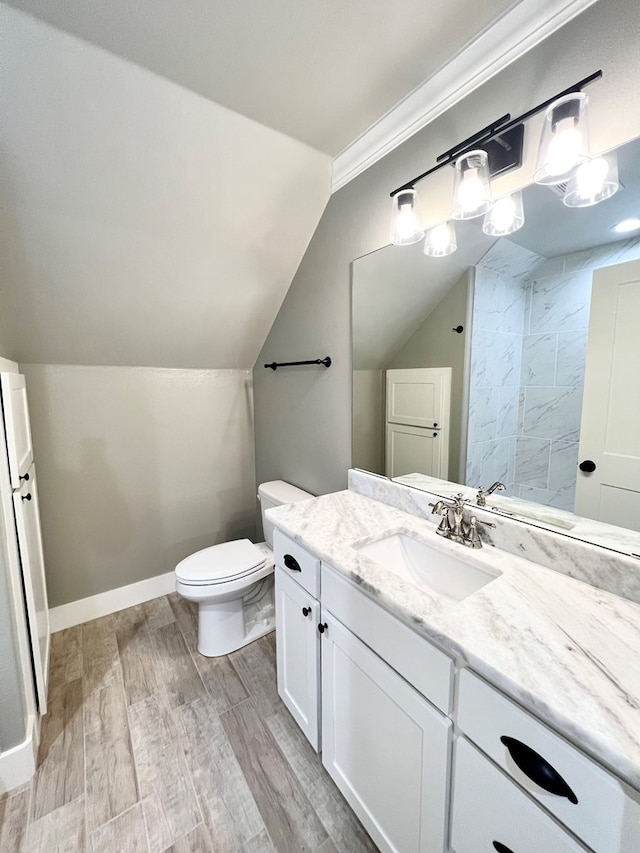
[466, 238, 640, 510]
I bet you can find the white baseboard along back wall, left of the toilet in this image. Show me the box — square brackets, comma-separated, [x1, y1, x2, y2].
[49, 572, 176, 634]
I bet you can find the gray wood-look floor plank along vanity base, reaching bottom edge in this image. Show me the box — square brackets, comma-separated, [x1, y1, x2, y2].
[267, 705, 378, 853]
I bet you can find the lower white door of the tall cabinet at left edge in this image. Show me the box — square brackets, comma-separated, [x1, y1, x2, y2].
[13, 465, 51, 714]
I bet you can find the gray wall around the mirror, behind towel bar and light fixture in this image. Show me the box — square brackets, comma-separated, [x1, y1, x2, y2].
[254, 0, 640, 493]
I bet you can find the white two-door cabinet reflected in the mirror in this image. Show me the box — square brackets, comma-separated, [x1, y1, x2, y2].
[385, 367, 451, 480]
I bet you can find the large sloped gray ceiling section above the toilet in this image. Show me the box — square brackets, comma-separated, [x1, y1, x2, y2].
[0, 3, 331, 368]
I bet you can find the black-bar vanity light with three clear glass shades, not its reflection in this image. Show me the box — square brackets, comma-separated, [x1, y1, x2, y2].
[390, 71, 602, 254]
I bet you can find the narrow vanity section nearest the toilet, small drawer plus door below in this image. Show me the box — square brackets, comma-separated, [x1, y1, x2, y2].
[273, 530, 320, 751]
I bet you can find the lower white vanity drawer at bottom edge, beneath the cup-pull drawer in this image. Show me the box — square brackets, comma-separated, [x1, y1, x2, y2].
[450, 738, 587, 853]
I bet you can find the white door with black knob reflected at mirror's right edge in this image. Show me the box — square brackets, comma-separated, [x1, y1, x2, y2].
[575, 261, 640, 530]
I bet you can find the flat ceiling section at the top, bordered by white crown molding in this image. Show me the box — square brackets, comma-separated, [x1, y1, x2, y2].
[3, 0, 517, 156]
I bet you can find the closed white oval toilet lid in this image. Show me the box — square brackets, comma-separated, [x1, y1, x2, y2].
[176, 539, 267, 584]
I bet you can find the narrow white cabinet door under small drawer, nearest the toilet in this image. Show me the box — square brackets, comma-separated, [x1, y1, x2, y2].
[275, 568, 320, 751]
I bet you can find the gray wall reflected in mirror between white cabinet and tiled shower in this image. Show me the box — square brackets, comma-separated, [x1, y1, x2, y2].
[388, 272, 470, 483]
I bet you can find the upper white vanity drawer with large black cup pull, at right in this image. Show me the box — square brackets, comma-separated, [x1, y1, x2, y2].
[457, 669, 640, 853]
